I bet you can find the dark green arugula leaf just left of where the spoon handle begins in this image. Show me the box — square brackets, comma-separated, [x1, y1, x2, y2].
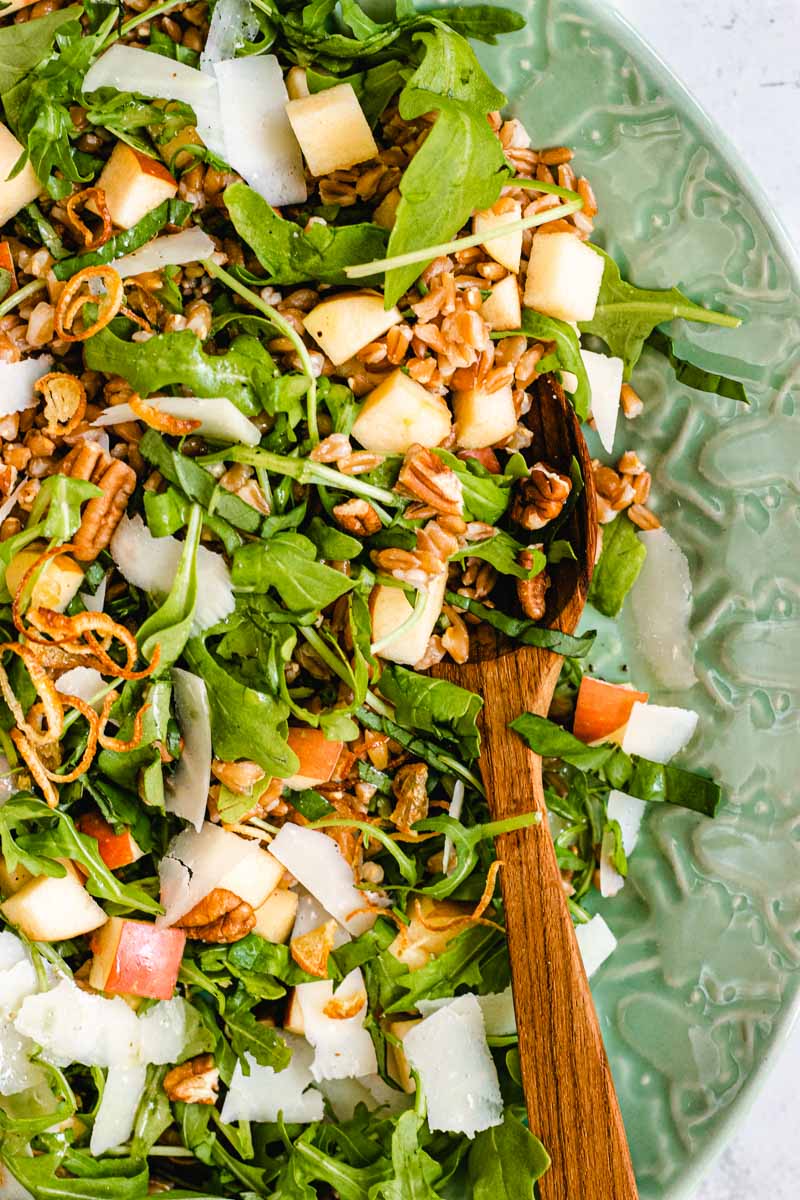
[378, 664, 483, 760]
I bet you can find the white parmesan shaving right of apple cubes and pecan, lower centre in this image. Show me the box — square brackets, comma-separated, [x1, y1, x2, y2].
[270, 824, 375, 936]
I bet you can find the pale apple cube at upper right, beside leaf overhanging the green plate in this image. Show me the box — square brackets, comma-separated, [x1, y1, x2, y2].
[524, 233, 603, 320]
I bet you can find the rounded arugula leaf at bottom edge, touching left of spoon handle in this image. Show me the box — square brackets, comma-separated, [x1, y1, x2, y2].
[468, 1110, 551, 1200]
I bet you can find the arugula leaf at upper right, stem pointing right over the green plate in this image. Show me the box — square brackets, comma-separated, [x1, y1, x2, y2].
[581, 242, 741, 379]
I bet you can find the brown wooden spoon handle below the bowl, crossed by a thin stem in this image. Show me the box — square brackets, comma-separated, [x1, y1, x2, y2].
[437, 652, 637, 1200]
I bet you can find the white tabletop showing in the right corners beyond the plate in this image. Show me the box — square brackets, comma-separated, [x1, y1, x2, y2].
[613, 0, 800, 1200]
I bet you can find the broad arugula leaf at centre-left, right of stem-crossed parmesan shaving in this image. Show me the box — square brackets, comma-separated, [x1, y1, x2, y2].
[230, 533, 354, 613]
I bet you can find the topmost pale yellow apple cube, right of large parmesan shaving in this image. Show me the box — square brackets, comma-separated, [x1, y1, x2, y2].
[287, 83, 378, 176]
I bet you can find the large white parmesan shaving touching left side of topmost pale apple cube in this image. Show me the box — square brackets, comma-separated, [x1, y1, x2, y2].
[213, 54, 308, 204]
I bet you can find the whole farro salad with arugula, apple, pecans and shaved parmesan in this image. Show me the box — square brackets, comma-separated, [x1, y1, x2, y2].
[0, 0, 746, 1200]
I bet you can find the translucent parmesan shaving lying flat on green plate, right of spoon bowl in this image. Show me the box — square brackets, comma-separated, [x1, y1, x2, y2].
[631, 529, 697, 691]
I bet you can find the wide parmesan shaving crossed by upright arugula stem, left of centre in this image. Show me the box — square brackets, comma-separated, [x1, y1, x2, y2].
[109, 513, 236, 632]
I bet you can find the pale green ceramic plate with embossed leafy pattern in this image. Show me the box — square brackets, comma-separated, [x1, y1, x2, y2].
[462, 0, 800, 1200]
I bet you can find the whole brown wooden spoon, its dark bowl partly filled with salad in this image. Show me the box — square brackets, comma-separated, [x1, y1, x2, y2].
[433, 377, 637, 1200]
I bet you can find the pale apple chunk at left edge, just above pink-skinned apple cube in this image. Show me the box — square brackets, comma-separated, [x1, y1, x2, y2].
[0, 869, 107, 942]
